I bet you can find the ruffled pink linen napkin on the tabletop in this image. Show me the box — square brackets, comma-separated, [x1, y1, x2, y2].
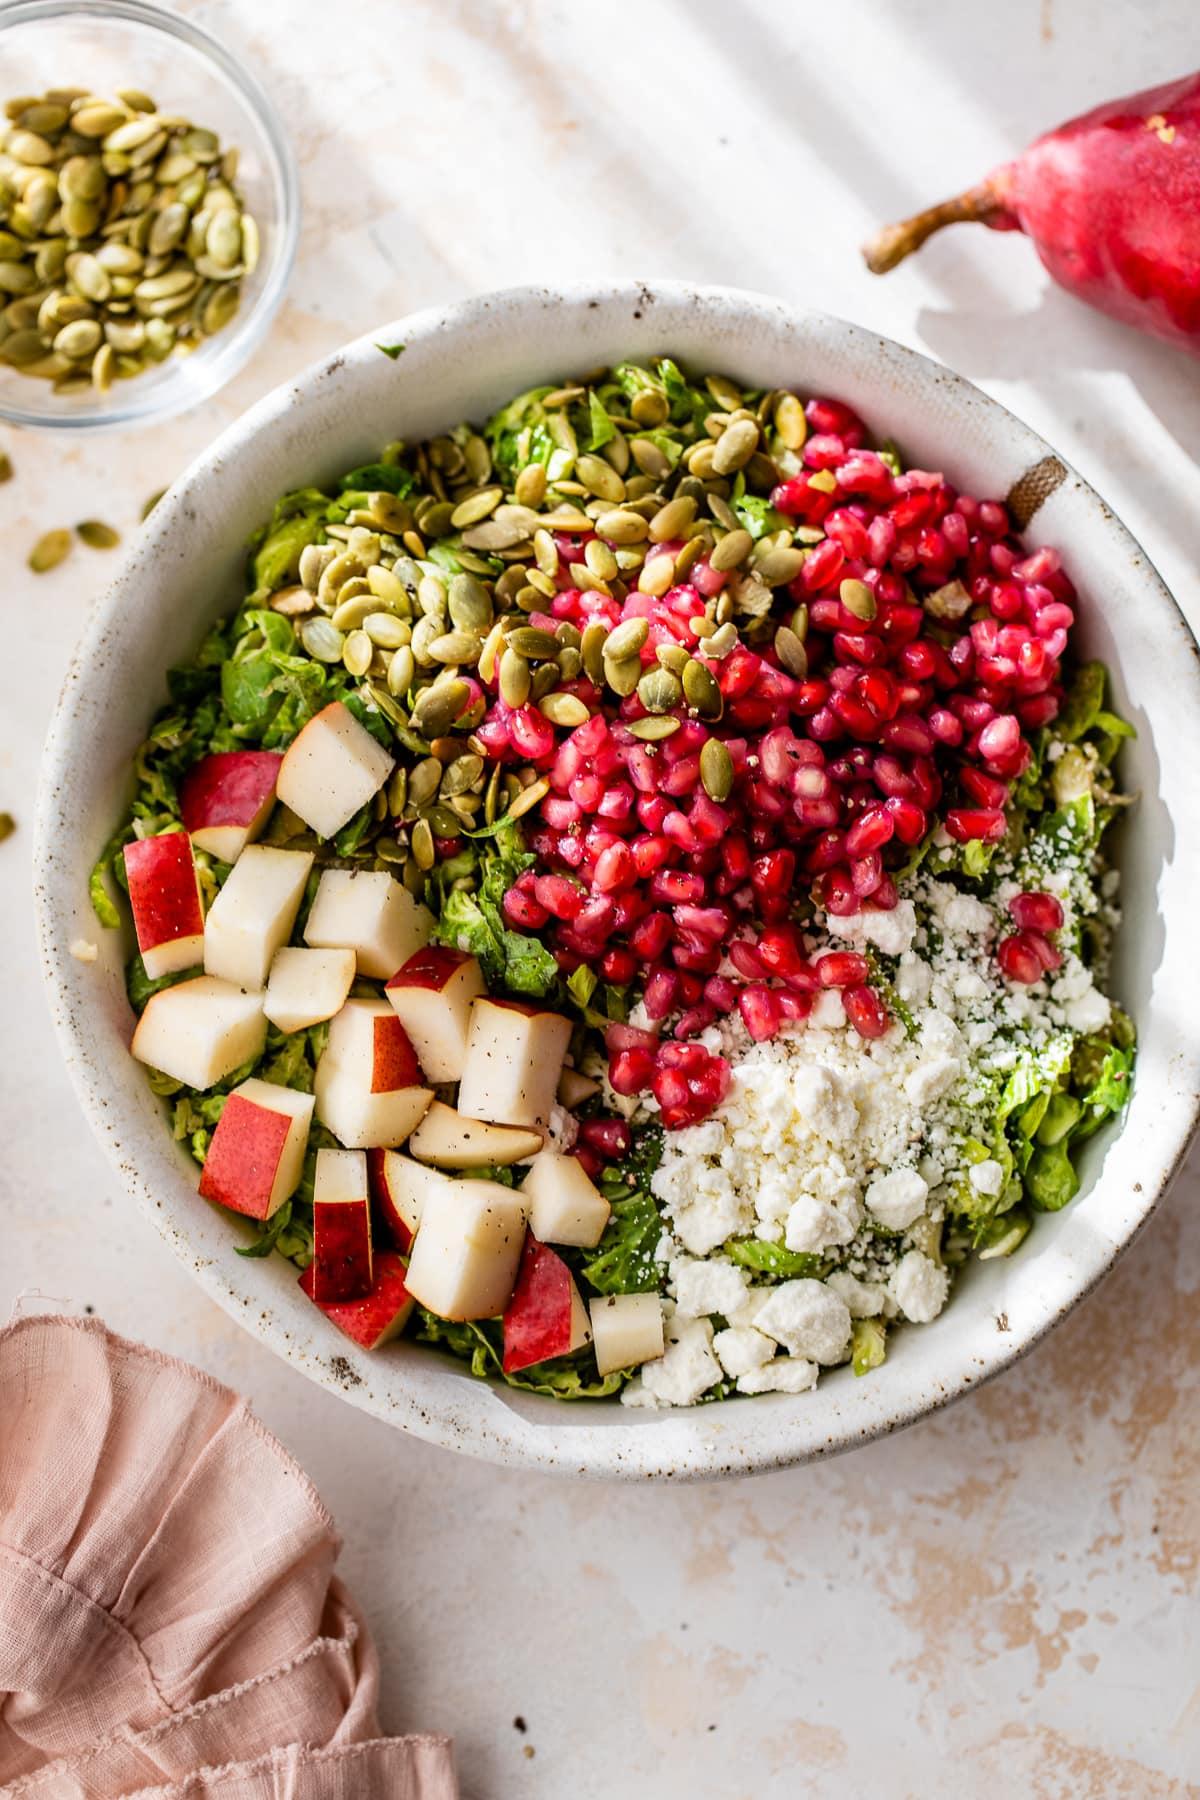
[0, 1318, 459, 1800]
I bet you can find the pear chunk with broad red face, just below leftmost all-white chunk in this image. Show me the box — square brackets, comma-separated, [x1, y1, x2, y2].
[200, 1076, 313, 1219]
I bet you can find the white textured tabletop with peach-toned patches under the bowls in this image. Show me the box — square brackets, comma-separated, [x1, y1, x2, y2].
[0, 0, 1200, 1800]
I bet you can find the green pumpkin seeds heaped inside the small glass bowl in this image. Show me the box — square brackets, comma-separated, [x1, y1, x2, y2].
[0, 88, 259, 392]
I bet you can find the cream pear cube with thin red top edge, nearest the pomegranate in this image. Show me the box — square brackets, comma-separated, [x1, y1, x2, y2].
[459, 999, 570, 1129]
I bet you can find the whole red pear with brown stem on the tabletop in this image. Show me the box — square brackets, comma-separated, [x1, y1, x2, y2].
[864, 72, 1200, 355]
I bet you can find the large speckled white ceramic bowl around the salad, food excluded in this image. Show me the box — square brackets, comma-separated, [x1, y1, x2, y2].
[36, 283, 1200, 1478]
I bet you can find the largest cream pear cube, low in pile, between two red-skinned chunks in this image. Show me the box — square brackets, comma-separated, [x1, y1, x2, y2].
[408, 1181, 525, 1319]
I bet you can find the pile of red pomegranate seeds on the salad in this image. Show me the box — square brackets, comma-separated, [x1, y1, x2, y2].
[475, 400, 1074, 1127]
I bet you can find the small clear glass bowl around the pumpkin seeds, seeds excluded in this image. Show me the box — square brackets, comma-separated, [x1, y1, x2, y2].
[0, 0, 300, 430]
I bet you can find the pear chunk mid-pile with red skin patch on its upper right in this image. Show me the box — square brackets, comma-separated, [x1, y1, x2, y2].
[313, 1001, 434, 1150]
